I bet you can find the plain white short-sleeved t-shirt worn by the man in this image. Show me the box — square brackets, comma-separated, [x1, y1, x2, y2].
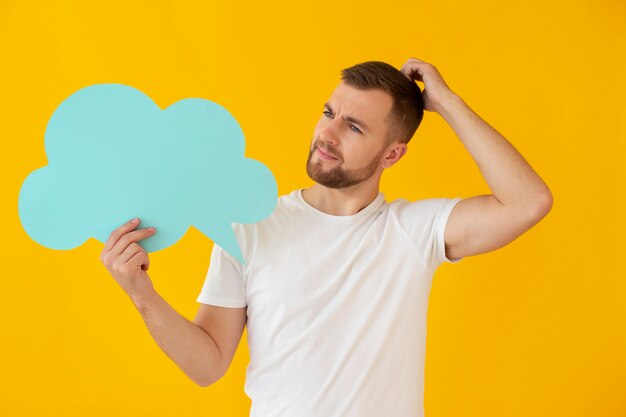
[197, 190, 463, 417]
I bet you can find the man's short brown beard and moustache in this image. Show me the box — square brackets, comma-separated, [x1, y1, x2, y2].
[306, 145, 385, 188]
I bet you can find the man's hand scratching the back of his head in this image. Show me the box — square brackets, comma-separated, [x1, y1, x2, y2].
[400, 58, 454, 113]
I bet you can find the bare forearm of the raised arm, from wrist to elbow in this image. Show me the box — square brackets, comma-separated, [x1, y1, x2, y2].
[439, 92, 552, 210]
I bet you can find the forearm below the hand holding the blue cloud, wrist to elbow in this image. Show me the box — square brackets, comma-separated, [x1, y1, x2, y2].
[132, 289, 223, 386]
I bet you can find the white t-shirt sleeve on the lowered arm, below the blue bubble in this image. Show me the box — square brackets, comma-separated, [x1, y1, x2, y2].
[196, 240, 247, 307]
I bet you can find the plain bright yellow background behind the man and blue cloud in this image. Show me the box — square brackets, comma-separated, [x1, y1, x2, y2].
[0, 0, 626, 417]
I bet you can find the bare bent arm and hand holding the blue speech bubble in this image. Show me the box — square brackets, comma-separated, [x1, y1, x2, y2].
[100, 220, 227, 387]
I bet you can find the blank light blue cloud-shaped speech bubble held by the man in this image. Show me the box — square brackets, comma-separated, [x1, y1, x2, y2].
[18, 84, 277, 262]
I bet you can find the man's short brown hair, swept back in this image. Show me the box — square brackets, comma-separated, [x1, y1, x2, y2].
[341, 61, 424, 143]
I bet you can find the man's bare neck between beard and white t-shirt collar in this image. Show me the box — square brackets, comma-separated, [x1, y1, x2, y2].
[302, 181, 379, 216]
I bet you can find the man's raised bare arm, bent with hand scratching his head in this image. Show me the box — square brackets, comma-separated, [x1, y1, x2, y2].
[401, 58, 552, 258]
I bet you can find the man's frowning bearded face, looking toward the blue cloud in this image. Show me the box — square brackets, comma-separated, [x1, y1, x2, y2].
[307, 81, 393, 188]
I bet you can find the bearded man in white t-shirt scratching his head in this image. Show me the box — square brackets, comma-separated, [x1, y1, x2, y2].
[101, 58, 552, 417]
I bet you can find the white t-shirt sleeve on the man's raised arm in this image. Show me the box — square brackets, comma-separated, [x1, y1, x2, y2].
[393, 197, 463, 267]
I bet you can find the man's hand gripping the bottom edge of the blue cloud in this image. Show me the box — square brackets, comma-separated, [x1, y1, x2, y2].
[100, 219, 156, 300]
